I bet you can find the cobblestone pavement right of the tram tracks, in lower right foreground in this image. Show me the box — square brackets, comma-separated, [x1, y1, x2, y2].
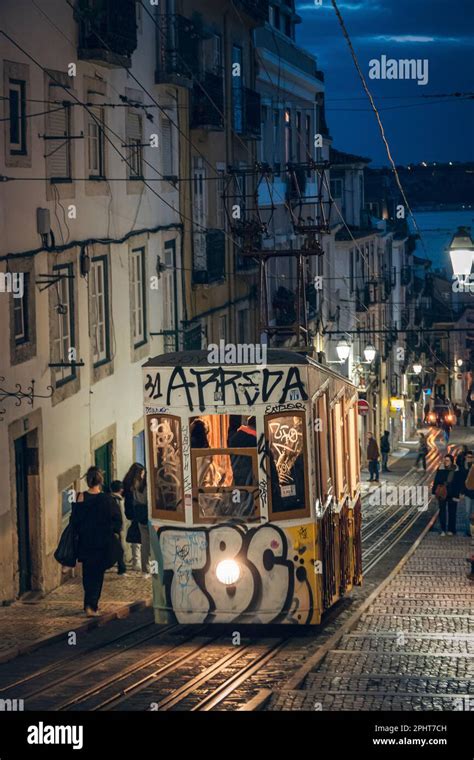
[266, 531, 474, 711]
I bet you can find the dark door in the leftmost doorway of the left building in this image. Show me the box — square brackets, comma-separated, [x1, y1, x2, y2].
[15, 435, 32, 595]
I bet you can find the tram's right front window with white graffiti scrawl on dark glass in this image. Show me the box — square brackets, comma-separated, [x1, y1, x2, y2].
[265, 412, 309, 519]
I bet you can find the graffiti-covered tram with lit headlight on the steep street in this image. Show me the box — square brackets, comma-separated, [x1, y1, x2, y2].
[143, 349, 362, 625]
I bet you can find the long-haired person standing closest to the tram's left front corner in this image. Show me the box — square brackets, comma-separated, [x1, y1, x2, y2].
[123, 462, 150, 578]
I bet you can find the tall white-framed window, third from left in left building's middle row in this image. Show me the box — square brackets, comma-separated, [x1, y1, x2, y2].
[89, 256, 110, 367]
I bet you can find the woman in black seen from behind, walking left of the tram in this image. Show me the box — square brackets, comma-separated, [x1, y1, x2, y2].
[71, 467, 121, 617]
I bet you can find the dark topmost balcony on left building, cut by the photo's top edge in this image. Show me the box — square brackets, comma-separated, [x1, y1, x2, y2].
[75, 0, 137, 68]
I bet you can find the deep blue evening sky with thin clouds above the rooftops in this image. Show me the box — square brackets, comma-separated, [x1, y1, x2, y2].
[296, 0, 474, 166]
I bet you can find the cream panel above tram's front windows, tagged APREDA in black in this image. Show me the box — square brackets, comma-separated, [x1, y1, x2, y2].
[143, 365, 308, 412]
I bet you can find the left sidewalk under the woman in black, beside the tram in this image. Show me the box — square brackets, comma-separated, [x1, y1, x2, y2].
[0, 568, 151, 662]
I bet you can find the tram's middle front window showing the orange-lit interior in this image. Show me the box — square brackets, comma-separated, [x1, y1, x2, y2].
[190, 414, 259, 522]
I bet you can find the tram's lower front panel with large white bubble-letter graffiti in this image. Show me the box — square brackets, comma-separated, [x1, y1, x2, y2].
[158, 524, 315, 624]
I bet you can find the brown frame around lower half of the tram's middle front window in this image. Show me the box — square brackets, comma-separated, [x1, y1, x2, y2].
[190, 446, 261, 524]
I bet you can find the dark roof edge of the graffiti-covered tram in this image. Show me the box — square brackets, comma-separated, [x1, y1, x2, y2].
[142, 348, 352, 385]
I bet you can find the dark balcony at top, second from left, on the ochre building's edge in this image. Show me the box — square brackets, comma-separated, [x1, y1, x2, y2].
[155, 13, 201, 88]
